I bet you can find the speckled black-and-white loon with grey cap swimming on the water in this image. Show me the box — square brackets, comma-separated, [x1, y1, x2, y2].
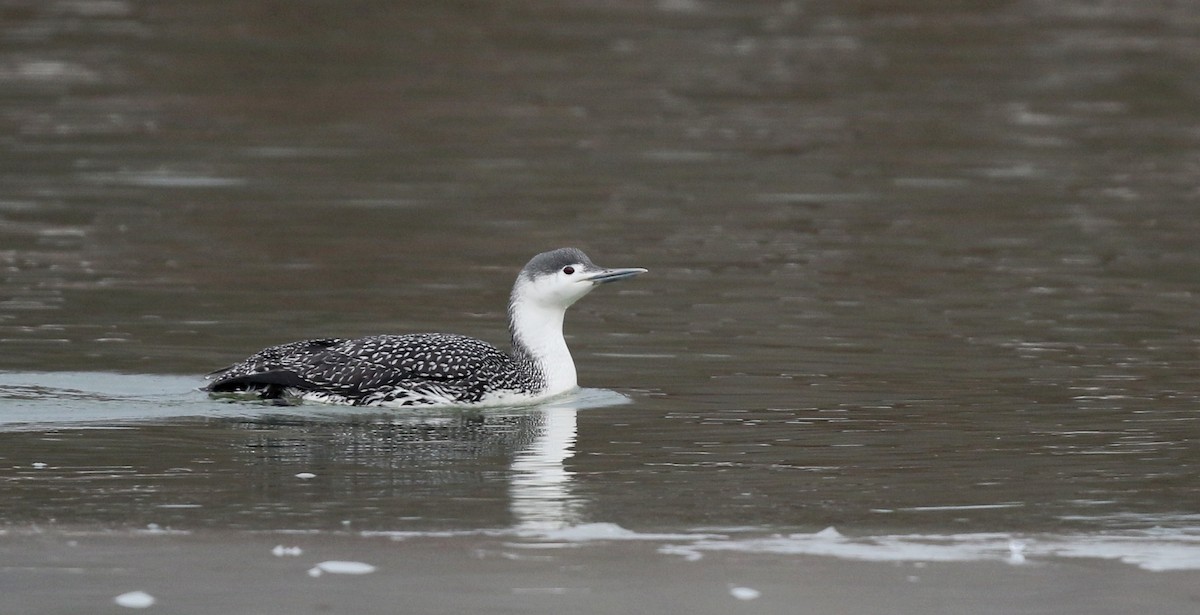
[204, 247, 646, 406]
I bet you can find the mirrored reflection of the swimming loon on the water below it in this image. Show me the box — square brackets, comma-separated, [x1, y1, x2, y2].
[220, 389, 628, 532]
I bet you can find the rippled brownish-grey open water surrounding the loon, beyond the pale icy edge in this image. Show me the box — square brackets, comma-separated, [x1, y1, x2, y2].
[0, 0, 1200, 565]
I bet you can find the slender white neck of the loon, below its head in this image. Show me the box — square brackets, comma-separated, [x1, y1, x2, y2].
[509, 297, 577, 395]
